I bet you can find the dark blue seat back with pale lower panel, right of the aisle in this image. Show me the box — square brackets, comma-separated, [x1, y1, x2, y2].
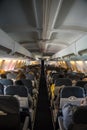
[60, 86, 85, 108]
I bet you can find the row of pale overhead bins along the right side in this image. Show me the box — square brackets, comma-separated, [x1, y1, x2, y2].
[52, 34, 87, 58]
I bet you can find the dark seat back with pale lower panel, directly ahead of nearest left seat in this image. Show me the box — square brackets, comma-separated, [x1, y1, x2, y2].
[6, 85, 31, 130]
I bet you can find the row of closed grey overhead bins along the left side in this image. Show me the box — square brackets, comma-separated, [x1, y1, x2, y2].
[0, 29, 33, 57]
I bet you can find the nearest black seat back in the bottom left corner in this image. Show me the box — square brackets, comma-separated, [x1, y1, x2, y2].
[0, 96, 20, 130]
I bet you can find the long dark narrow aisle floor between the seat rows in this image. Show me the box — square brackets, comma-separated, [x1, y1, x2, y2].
[33, 61, 54, 130]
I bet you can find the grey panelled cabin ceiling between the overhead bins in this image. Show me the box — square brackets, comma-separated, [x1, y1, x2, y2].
[0, 0, 87, 59]
